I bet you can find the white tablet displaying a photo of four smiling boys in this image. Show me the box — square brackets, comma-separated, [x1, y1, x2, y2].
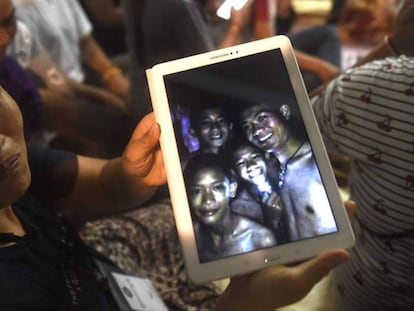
[146, 36, 354, 283]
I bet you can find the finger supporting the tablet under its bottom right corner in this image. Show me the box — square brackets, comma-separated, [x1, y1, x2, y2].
[292, 249, 349, 288]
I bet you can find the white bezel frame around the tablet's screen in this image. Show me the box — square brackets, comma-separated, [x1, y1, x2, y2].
[146, 36, 354, 283]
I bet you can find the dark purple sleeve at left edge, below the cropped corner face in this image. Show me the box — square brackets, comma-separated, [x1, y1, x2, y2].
[0, 56, 44, 140]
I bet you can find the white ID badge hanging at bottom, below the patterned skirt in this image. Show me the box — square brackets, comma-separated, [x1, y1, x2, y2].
[95, 260, 168, 311]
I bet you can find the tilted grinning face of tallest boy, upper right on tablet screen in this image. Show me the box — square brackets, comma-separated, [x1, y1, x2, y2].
[242, 106, 288, 152]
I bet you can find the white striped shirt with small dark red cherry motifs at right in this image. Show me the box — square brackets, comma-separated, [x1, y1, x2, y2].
[314, 56, 414, 311]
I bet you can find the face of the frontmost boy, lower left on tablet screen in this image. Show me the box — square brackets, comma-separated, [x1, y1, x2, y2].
[189, 167, 231, 225]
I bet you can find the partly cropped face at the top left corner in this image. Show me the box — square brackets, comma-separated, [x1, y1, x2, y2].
[0, 0, 16, 61]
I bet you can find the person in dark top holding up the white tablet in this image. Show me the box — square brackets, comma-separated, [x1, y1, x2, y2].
[0, 80, 354, 310]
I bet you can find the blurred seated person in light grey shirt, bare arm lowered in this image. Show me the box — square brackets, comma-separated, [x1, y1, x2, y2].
[13, 0, 129, 109]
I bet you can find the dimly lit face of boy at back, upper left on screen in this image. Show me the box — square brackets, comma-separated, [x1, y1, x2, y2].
[199, 108, 230, 148]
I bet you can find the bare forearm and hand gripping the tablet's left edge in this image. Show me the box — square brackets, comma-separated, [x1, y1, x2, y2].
[56, 114, 166, 225]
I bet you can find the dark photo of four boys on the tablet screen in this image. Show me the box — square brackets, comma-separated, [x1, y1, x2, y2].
[164, 50, 337, 262]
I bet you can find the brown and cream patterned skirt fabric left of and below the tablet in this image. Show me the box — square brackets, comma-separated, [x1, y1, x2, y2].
[81, 203, 220, 311]
